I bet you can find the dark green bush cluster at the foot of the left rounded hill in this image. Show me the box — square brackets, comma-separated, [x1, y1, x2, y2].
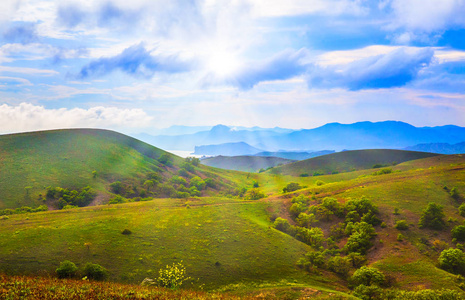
[46, 186, 97, 209]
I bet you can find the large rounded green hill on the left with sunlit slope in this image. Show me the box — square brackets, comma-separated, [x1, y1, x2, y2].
[0, 129, 234, 209]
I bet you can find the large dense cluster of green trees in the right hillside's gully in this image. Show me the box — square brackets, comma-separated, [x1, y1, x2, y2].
[273, 194, 381, 277]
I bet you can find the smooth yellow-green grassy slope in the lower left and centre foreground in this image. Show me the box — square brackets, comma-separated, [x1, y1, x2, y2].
[0, 198, 350, 296]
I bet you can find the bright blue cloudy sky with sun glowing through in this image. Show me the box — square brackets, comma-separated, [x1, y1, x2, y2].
[0, 0, 465, 133]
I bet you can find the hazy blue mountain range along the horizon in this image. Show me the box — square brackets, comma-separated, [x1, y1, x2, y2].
[134, 121, 465, 152]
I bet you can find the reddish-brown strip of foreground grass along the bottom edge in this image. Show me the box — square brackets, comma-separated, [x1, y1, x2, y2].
[0, 274, 352, 300]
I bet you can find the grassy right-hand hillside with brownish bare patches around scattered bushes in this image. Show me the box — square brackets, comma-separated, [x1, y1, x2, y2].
[264, 155, 465, 290]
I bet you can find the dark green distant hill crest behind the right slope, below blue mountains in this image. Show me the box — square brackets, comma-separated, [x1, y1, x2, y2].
[269, 149, 438, 176]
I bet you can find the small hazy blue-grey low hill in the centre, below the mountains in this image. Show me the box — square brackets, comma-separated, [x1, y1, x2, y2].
[201, 155, 293, 172]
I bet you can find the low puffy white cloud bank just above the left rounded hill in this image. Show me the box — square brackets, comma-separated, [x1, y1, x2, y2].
[0, 103, 152, 133]
